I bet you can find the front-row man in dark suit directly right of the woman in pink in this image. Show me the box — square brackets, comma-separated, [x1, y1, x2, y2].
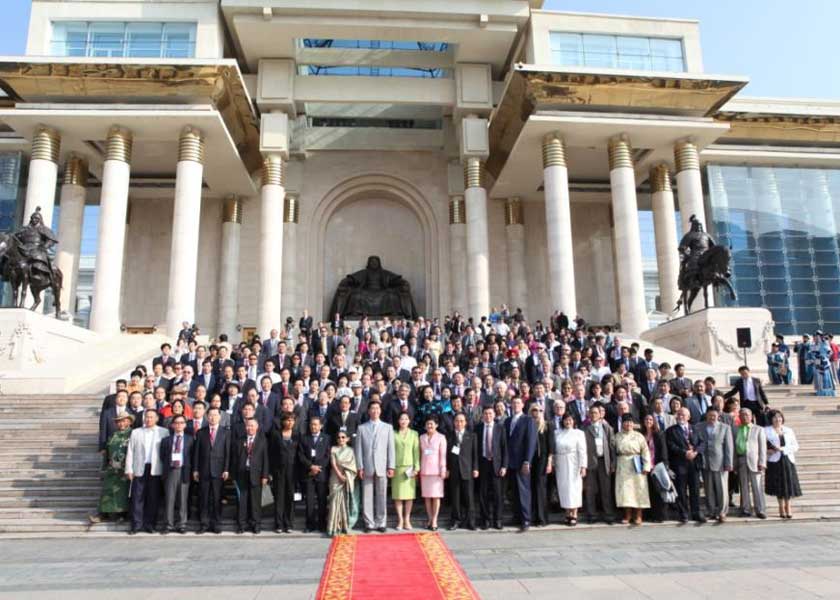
[446, 413, 478, 531]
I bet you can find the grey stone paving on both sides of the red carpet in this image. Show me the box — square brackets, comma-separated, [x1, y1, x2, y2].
[0, 521, 840, 600]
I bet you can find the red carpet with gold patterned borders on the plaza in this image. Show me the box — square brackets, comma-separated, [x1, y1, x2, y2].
[316, 533, 478, 600]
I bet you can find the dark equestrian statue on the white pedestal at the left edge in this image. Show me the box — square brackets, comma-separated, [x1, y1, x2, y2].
[0, 206, 63, 318]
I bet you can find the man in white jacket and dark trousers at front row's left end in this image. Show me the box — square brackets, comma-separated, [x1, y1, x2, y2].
[125, 408, 169, 535]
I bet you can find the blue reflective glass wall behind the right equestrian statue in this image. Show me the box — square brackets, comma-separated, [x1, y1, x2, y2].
[706, 165, 840, 334]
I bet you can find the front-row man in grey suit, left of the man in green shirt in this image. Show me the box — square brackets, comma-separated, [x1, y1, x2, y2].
[696, 407, 733, 523]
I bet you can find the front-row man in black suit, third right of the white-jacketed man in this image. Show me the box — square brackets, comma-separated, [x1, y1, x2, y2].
[231, 418, 268, 533]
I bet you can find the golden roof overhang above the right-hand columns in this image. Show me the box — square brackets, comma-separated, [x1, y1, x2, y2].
[487, 64, 748, 183]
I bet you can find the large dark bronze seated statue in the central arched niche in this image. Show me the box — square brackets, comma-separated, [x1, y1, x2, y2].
[330, 256, 417, 319]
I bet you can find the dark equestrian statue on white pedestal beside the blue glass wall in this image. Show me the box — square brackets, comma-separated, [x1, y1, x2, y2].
[674, 215, 736, 314]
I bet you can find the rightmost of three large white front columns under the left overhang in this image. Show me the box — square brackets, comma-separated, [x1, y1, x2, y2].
[166, 127, 204, 337]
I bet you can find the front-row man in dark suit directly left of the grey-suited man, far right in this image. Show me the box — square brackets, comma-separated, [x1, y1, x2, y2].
[665, 407, 706, 523]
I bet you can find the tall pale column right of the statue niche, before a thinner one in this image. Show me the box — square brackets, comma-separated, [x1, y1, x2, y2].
[464, 158, 490, 323]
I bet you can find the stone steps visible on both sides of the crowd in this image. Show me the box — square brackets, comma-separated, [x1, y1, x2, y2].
[0, 386, 840, 535]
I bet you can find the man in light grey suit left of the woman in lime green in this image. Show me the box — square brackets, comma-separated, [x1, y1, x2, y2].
[356, 401, 396, 533]
